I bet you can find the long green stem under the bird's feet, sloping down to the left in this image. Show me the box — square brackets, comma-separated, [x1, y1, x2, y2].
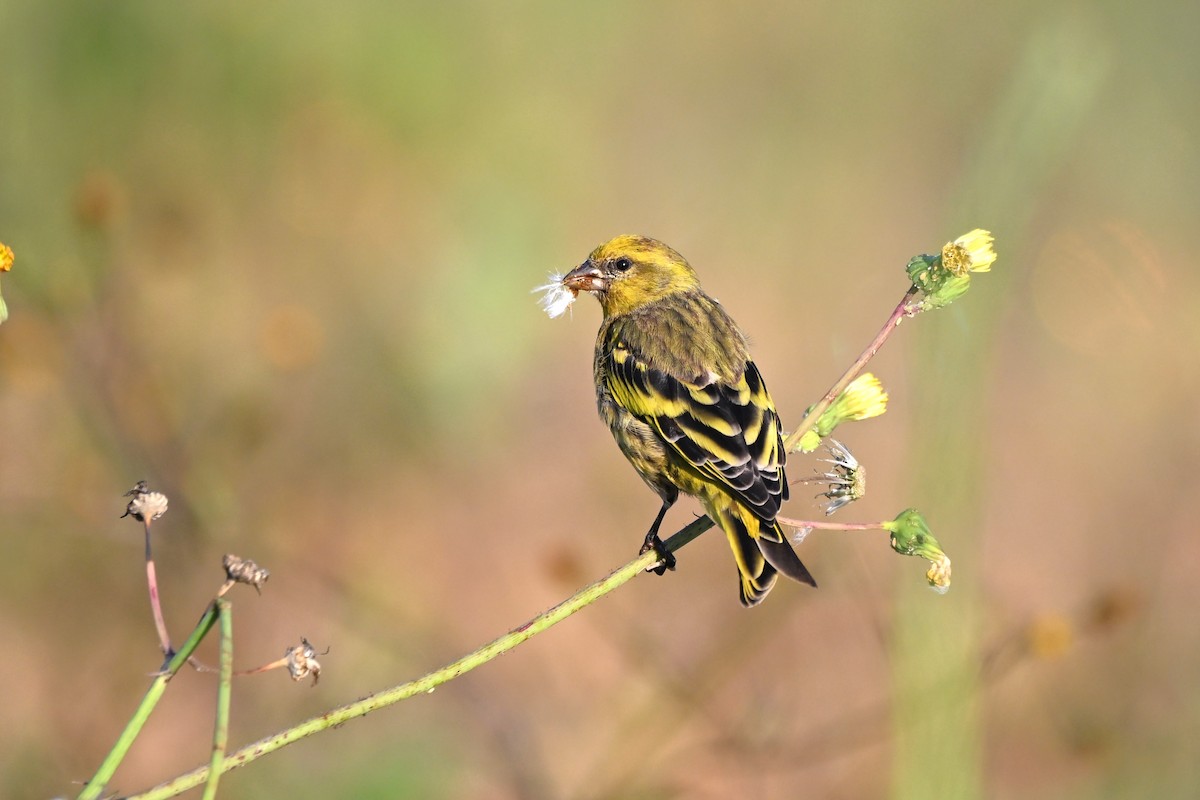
[128, 517, 713, 800]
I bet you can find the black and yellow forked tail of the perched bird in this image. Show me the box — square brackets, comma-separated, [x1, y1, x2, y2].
[716, 507, 817, 608]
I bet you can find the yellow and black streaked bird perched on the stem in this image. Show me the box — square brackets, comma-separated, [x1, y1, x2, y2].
[562, 235, 816, 608]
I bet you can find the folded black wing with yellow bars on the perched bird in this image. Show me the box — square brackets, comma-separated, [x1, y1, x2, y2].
[605, 339, 787, 530]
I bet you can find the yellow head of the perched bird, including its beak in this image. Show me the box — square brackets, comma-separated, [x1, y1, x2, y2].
[563, 234, 700, 317]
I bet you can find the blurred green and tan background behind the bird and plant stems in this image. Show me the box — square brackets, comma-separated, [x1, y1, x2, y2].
[0, 0, 1200, 800]
